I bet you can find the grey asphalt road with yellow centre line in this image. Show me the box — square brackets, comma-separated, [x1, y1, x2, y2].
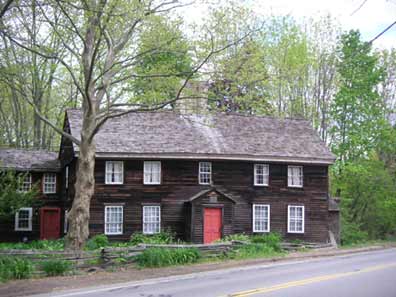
[35, 249, 396, 297]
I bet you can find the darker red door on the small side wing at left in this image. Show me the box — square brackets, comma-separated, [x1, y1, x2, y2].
[40, 207, 60, 239]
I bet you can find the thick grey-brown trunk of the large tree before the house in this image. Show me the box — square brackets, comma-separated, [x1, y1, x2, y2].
[65, 115, 96, 252]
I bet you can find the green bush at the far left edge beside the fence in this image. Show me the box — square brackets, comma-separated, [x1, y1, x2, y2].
[0, 257, 34, 281]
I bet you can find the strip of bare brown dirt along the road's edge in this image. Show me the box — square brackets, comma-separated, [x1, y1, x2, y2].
[0, 245, 395, 297]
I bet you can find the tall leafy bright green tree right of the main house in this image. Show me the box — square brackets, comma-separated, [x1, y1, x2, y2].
[331, 31, 386, 162]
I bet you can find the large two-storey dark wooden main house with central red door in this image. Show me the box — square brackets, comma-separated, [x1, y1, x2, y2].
[0, 109, 338, 243]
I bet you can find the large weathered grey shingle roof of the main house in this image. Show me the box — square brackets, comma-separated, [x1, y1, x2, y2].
[67, 109, 335, 164]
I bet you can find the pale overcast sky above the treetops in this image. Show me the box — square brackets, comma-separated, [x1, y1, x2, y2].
[183, 0, 396, 49]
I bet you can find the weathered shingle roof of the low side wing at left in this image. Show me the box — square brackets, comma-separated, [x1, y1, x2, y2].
[0, 148, 60, 172]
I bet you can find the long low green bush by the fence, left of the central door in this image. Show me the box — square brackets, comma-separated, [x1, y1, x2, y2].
[136, 248, 201, 267]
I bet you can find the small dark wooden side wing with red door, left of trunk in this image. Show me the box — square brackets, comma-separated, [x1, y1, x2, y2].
[0, 148, 65, 241]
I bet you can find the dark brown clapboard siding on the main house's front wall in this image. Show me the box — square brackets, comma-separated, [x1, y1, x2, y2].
[84, 159, 328, 242]
